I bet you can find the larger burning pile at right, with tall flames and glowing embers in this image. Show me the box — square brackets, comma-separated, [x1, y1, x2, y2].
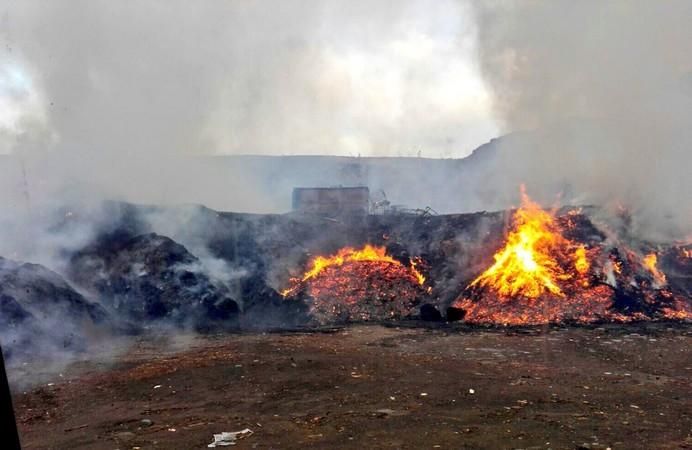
[450, 188, 692, 325]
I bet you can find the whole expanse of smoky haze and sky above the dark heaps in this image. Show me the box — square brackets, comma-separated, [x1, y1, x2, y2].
[0, 0, 692, 236]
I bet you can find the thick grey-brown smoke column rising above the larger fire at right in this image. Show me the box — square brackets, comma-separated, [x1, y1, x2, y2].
[475, 0, 692, 236]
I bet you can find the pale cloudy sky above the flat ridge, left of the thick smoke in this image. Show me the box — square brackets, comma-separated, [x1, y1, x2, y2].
[0, 0, 498, 157]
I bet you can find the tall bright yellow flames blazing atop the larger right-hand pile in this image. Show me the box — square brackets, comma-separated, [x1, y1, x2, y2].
[469, 186, 589, 298]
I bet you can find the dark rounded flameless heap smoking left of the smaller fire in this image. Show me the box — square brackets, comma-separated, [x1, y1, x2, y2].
[69, 233, 239, 328]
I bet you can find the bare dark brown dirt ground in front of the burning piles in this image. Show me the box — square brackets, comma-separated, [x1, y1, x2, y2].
[10, 324, 692, 450]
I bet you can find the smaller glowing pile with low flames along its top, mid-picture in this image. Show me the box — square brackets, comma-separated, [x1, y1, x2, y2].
[281, 245, 428, 324]
